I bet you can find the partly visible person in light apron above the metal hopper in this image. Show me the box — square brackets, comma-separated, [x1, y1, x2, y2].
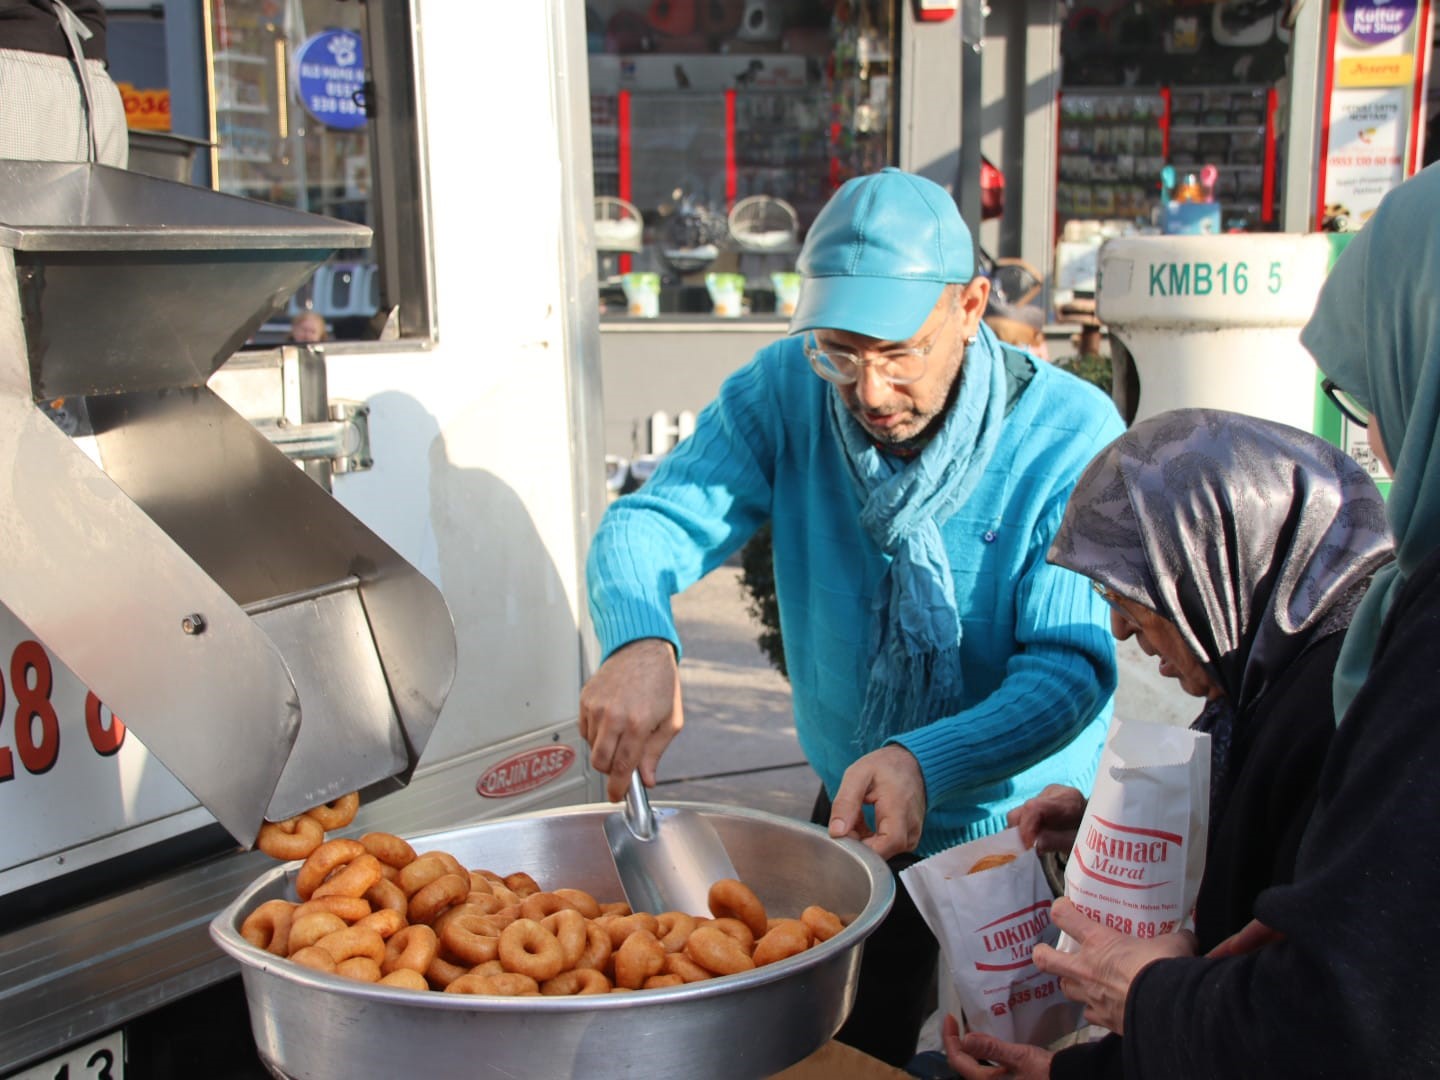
[0, 0, 130, 168]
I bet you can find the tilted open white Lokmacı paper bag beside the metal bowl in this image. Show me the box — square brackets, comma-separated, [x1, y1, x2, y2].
[900, 829, 1081, 1045]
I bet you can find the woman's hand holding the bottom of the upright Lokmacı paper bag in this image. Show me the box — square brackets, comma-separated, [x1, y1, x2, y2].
[1032, 899, 1198, 1035]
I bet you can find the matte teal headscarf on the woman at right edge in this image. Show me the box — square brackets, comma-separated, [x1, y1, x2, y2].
[1300, 166, 1440, 723]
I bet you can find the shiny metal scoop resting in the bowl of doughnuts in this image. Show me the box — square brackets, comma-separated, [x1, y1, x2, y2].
[605, 770, 736, 914]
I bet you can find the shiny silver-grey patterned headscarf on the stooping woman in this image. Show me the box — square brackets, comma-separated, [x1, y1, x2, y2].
[1048, 409, 1391, 821]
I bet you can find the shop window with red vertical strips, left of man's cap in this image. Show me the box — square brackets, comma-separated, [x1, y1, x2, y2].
[586, 0, 899, 315]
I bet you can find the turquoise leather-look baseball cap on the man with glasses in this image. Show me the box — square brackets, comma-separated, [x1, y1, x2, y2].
[791, 168, 975, 341]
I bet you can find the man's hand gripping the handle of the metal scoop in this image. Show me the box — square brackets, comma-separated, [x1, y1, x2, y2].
[580, 638, 685, 802]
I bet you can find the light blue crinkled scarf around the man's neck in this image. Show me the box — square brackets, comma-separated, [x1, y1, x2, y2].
[829, 325, 1005, 753]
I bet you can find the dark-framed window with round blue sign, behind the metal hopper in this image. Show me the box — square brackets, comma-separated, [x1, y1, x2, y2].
[204, 0, 433, 344]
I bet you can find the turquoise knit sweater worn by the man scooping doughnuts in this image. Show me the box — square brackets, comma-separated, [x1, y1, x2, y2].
[588, 338, 1123, 855]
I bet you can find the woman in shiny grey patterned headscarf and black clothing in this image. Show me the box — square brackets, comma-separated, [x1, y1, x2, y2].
[946, 409, 1391, 1079]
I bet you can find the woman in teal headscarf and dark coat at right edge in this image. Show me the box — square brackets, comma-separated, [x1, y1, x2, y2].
[953, 166, 1440, 1079]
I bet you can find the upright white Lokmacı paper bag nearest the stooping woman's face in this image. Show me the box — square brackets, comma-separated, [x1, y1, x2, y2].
[1058, 720, 1210, 952]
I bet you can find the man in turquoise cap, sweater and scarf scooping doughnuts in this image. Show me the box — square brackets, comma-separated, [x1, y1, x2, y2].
[580, 168, 1123, 1066]
